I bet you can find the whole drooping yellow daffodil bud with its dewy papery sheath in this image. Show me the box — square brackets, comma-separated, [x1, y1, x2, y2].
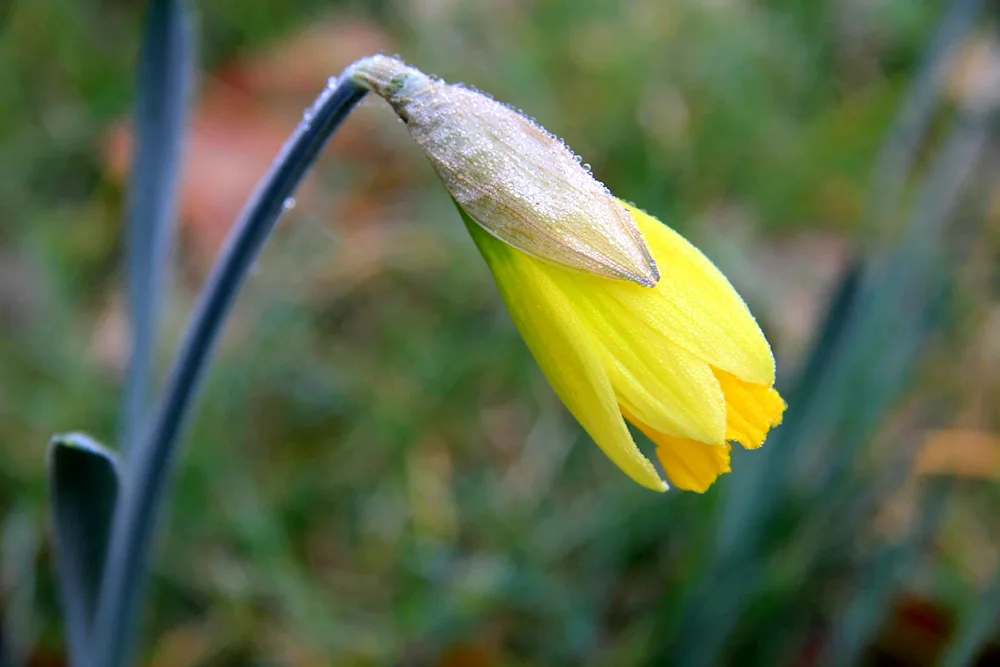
[345, 56, 785, 492]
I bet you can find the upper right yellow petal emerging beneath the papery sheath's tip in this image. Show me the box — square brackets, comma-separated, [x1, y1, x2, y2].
[564, 204, 774, 386]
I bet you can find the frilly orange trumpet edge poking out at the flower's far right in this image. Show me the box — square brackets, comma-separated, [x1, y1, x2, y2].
[715, 369, 785, 449]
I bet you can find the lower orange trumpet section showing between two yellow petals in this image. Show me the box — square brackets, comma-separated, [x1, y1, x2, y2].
[625, 409, 730, 493]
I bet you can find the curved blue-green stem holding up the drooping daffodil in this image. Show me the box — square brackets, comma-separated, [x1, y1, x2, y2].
[90, 81, 366, 667]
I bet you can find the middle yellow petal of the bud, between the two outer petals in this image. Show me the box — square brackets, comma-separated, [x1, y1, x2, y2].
[543, 274, 726, 445]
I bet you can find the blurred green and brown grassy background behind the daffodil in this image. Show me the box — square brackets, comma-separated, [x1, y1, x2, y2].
[0, 0, 1000, 667]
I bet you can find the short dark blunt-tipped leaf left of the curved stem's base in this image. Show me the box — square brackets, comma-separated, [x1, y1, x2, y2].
[49, 433, 120, 665]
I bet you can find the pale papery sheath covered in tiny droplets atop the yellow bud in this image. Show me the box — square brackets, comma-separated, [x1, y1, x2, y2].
[346, 56, 659, 287]
